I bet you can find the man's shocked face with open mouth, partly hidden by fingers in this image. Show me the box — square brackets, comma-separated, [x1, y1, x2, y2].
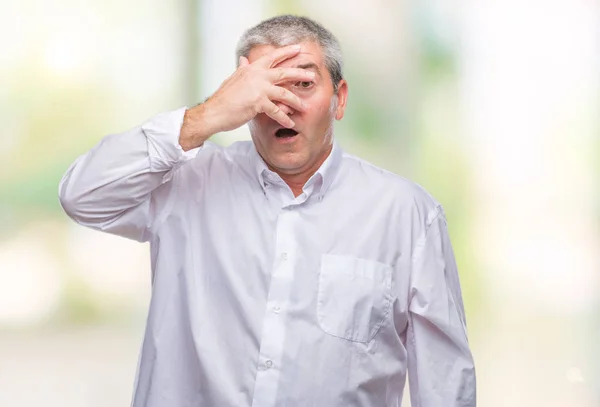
[248, 42, 348, 175]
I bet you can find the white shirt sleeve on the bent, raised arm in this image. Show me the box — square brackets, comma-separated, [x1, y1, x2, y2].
[59, 107, 198, 241]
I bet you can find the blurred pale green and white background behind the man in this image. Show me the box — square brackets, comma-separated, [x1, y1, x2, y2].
[0, 0, 600, 407]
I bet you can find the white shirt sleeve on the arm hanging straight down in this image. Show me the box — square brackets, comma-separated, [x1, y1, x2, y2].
[407, 207, 476, 407]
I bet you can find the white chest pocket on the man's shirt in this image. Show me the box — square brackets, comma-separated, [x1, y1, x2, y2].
[317, 254, 392, 342]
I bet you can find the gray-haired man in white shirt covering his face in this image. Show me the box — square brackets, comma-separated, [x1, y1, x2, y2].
[60, 16, 475, 407]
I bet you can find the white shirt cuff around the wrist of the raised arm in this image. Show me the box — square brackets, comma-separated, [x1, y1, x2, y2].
[142, 106, 201, 173]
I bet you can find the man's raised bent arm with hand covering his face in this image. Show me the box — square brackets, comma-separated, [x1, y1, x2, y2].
[59, 46, 314, 241]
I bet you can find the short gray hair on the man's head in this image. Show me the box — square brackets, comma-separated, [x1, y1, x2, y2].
[236, 15, 344, 93]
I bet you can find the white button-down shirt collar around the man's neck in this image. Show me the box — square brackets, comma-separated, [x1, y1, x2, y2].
[250, 139, 343, 199]
